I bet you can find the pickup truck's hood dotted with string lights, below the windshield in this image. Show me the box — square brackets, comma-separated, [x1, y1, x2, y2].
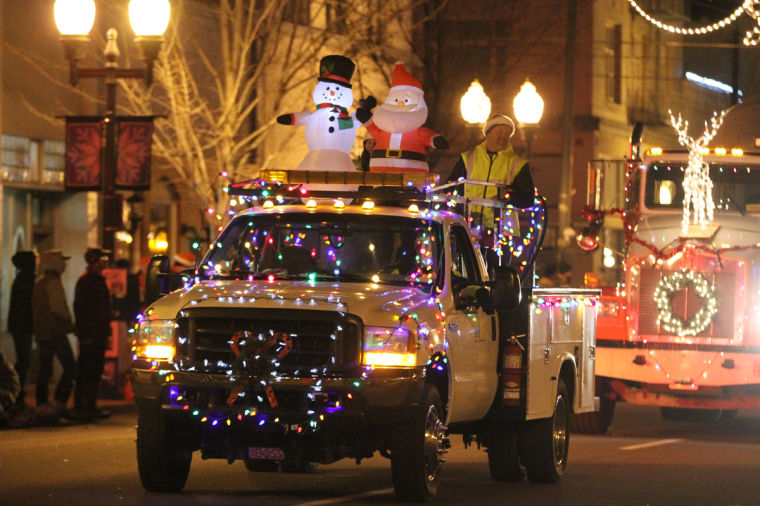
[148, 280, 435, 326]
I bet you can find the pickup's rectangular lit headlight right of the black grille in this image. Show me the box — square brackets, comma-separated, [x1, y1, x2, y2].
[363, 326, 417, 367]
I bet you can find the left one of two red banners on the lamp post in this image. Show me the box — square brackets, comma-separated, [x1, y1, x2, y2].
[64, 116, 103, 191]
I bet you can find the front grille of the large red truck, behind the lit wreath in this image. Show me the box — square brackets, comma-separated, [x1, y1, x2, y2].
[639, 269, 736, 339]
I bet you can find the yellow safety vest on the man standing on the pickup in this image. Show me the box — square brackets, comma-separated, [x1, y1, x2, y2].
[462, 142, 525, 228]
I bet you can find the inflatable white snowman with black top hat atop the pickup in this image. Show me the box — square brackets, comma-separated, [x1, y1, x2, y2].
[277, 55, 376, 171]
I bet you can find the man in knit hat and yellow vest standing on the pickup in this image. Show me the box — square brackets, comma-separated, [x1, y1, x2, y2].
[448, 114, 536, 245]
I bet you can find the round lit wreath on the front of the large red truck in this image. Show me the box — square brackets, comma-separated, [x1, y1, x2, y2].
[654, 269, 718, 336]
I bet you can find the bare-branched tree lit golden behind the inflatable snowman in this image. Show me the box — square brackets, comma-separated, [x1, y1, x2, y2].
[117, 0, 446, 225]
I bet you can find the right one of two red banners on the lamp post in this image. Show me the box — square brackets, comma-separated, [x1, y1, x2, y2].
[114, 116, 153, 190]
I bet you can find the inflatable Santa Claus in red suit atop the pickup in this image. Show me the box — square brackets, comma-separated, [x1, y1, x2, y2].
[365, 63, 449, 172]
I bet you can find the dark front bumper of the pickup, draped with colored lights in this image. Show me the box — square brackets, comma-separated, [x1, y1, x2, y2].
[130, 368, 424, 430]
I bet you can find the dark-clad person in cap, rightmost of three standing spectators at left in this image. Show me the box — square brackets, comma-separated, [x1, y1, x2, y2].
[72, 248, 111, 420]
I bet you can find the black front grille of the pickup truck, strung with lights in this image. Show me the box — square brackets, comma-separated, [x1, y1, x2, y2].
[176, 308, 362, 376]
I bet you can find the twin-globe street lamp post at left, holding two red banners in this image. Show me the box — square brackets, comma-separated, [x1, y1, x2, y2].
[54, 0, 171, 251]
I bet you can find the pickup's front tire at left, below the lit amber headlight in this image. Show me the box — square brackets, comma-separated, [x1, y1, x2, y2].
[137, 406, 193, 492]
